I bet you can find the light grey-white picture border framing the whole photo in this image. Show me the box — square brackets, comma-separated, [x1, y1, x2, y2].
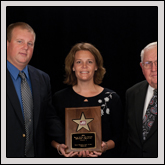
[1, 1, 164, 164]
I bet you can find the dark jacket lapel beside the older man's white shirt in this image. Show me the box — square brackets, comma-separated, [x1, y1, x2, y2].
[135, 82, 148, 142]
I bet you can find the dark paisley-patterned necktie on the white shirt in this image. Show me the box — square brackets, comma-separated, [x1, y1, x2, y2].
[143, 89, 157, 140]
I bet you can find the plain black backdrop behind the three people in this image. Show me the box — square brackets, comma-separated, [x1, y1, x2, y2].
[6, 6, 158, 157]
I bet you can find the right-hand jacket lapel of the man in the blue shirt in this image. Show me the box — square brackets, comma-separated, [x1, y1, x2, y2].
[28, 66, 40, 129]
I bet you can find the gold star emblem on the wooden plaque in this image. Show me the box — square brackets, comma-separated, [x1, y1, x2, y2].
[73, 112, 93, 131]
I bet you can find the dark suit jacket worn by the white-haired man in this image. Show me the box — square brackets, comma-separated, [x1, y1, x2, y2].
[123, 81, 158, 158]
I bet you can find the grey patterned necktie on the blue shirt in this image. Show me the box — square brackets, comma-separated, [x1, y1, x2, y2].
[19, 72, 34, 157]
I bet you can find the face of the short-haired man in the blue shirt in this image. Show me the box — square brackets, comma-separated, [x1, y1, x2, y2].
[7, 27, 35, 70]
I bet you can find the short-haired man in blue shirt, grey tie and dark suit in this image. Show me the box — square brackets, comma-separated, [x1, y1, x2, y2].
[6, 22, 64, 157]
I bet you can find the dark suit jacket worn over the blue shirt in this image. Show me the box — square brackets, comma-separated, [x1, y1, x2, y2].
[6, 65, 64, 157]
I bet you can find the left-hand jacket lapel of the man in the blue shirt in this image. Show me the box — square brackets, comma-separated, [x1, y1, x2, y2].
[7, 70, 24, 126]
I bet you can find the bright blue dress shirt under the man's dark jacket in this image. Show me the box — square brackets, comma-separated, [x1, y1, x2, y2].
[7, 61, 32, 117]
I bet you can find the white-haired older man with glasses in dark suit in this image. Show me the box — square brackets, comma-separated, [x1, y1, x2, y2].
[123, 42, 158, 158]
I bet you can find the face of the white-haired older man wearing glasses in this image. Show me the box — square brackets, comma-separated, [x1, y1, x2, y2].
[140, 46, 157, 89]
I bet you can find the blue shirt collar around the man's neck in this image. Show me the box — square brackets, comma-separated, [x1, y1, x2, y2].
[7, 61, 29, 80]
